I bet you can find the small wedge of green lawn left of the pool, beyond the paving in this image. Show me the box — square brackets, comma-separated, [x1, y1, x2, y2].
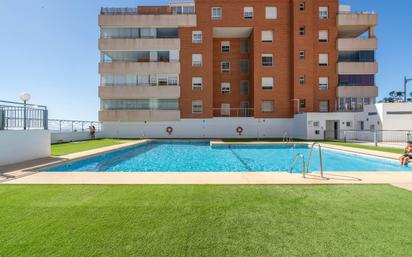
[51, 139, 129, 156]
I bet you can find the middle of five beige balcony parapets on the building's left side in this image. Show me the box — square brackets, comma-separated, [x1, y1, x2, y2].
[99, 62, 180, 74]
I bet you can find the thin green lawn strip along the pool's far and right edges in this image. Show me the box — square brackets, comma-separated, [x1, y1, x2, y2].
[223, 138, 406, 154]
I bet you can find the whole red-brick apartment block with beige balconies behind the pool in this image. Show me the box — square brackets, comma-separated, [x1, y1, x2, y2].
[99, 0, 378, 138]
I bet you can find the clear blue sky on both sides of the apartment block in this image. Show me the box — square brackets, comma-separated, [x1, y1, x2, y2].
[0, 0, 412, 120]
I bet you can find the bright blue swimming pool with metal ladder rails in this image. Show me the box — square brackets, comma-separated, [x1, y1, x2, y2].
[45, 142, 412, 173]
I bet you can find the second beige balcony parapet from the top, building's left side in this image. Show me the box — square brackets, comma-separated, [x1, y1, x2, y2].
[99, 38, 180, 51]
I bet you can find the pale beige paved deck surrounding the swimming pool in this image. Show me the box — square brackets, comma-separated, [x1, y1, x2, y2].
[0, 140, 412, 191]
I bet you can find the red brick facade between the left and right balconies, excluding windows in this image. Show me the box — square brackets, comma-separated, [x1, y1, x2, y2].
[179, 0, 338, 118]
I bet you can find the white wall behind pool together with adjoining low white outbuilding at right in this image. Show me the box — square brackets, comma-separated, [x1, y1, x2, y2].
[102, 103, 412, 141]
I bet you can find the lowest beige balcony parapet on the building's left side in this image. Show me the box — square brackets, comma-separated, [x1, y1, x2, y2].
[99, 110, 180, 122]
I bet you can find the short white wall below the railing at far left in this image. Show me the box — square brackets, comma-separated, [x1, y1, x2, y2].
[0, 130, 50, 166]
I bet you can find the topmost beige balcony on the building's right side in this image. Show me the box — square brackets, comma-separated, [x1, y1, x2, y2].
[337, 13, 378, 38]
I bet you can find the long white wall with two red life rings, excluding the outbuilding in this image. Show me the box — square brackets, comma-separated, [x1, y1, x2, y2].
[102, 118, 293, 138]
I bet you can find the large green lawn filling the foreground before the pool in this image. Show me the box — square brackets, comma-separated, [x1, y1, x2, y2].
[0, 185, 412, 257]
